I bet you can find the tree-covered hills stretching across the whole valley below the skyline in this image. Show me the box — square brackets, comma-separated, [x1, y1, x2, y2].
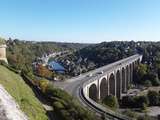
[6, 39, 160, 79]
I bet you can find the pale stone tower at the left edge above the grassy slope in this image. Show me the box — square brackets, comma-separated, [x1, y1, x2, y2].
[0, 44, 8, 63]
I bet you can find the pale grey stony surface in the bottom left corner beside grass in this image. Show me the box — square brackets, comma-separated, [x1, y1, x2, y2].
[0, 85, 28, 120]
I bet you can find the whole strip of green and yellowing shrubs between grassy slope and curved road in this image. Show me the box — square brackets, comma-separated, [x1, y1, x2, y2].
[25, 71, 95, 120]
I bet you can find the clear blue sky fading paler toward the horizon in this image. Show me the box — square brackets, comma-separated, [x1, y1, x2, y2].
[0, 0, 160, 43]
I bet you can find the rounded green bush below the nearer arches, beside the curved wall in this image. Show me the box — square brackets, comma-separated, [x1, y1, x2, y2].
[102, 95, 118, 108]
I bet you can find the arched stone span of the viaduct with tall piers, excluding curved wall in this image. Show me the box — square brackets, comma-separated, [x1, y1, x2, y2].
[84, 55, 142, 101]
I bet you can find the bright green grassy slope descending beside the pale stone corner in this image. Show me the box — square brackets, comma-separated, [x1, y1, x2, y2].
[0, 65, 47, 120]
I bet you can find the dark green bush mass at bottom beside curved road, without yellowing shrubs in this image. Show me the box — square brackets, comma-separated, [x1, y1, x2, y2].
[45, 85, 94, 120]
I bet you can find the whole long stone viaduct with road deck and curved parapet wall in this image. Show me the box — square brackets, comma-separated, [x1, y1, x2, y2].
[55, 54, 142, 119]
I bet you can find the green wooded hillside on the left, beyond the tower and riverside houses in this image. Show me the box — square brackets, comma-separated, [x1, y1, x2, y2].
[7, 38, 88, 71]
